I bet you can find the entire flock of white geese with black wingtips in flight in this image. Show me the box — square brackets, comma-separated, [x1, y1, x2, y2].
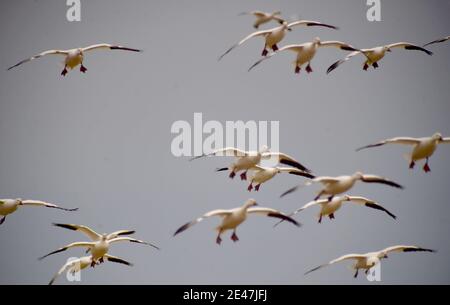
[0, 11, 450, 284]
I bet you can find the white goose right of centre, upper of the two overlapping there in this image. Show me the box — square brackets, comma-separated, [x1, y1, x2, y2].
[281, 172, 403, 201]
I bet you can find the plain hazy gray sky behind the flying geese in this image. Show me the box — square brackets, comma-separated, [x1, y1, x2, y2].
[0, 0, 450, 284]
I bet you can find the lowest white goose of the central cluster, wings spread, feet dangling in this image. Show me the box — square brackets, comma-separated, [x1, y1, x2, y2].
[174, 199, 300, 245]
